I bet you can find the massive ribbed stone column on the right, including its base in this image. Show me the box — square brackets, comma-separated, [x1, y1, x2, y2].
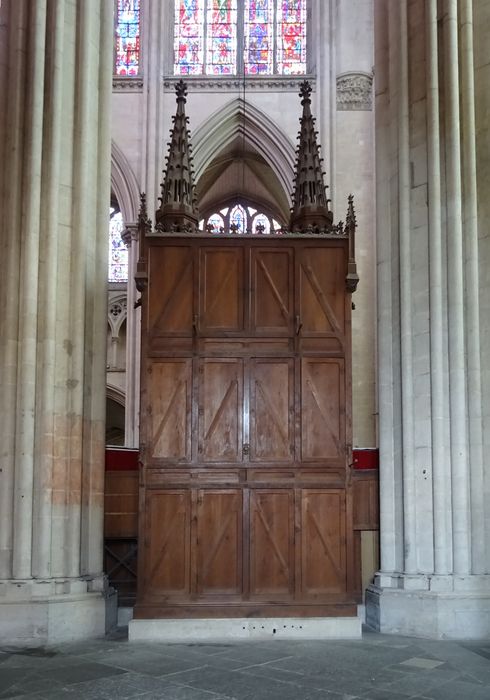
[367, 0, 490, 638]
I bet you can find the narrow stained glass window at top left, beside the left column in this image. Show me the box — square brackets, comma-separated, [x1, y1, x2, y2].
[116, 0, 140, 75]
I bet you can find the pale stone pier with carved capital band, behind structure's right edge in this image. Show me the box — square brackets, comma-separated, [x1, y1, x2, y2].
[334, 0, 377, 447]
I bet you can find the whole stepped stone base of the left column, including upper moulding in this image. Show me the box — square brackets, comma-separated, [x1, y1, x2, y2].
[0, 579, 112, 647]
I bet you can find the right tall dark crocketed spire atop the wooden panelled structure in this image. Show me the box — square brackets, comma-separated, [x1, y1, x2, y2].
[290, 80, 333, 231]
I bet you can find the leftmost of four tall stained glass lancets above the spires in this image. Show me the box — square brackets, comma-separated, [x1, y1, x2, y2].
[174, 0, 205, 75]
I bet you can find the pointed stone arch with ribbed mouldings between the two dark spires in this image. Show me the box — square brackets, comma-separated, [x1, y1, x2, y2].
[192, 97, 295, 206]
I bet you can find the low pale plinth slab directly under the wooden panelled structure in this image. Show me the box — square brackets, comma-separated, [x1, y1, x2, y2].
[128, 617, 361, 642]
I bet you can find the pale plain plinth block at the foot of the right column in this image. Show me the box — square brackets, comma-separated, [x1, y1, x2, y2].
[366, 585, 490, 639]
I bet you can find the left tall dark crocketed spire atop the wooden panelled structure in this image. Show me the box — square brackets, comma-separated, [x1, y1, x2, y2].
[156, 80, 199, 231]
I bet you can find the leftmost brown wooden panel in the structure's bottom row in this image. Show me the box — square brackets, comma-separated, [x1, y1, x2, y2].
[145, 490, 191, 596]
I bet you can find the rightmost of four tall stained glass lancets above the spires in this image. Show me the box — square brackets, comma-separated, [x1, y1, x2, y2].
[277, 0, 306, 75]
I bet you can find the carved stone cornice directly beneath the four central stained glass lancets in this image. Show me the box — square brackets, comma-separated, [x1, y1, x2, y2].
[163, 75, 315, 92]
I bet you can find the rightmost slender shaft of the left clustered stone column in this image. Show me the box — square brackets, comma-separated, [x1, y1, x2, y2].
[80, 1, 114, 575]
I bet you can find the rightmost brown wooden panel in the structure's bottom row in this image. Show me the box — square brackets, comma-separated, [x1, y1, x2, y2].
[301, 489, 346, 596]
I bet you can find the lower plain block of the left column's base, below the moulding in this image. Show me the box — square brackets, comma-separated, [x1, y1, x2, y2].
[0, 592, 106, 647]
